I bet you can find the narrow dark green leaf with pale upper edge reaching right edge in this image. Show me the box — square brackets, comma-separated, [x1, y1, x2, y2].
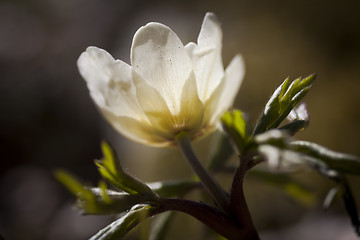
[290, 141, 360, 175]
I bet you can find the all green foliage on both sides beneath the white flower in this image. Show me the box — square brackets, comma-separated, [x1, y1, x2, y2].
[55, 72, 360, 240]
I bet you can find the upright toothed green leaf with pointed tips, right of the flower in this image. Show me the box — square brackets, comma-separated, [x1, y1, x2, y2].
[254, 74, 316, 135]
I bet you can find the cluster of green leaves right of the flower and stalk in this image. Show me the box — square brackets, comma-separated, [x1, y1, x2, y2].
[217, 75, 360, 238]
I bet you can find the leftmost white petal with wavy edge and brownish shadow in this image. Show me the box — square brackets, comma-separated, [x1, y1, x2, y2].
[77, 47, 146, 120]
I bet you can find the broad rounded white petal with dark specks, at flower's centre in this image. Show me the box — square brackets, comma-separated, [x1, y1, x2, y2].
[131, 23, 192, 114]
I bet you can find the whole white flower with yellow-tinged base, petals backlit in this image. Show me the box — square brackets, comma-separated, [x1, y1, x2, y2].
[77, 13, 244, 146]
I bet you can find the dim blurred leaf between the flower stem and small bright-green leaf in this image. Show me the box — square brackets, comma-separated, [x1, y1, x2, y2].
[207, 131, 234, 172]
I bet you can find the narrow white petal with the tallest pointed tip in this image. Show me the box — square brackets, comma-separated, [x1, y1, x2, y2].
[191, 13, 224, 102]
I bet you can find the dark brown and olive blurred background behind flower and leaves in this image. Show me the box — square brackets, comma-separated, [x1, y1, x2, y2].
[0, 0, 360, 240]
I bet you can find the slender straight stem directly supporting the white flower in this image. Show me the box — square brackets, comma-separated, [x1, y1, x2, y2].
[175, 132, 231, 215]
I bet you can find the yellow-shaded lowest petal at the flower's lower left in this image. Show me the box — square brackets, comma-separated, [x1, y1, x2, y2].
[103, 110, 173, 147]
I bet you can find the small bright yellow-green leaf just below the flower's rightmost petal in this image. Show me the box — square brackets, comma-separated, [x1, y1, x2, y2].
[221, 110, 249, 153]
